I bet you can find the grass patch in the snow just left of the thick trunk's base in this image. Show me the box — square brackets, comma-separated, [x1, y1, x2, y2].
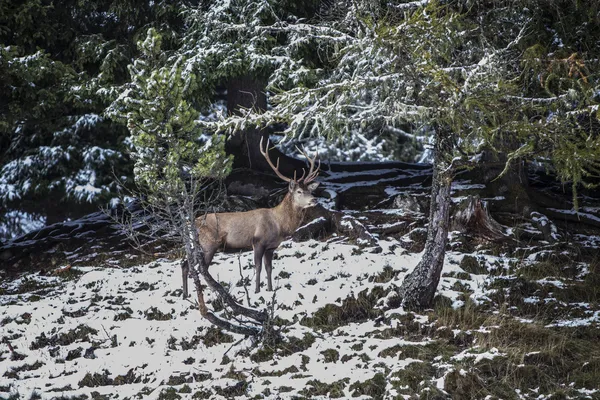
[300, 286, 389, 332]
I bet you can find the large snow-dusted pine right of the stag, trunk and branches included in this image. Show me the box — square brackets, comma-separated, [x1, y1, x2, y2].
[205, 0, 599, 307]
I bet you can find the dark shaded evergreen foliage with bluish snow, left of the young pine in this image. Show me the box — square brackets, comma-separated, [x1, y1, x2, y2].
[0, 0, 183, 231]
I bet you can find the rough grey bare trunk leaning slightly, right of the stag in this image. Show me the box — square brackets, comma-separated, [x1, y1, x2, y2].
[399, 133, 453, 309]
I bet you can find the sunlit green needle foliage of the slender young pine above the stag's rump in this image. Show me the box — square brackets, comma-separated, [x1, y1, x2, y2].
[108, 28, 231, 198]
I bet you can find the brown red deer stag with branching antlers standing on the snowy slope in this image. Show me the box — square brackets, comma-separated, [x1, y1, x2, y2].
[181, 140, 320, 298]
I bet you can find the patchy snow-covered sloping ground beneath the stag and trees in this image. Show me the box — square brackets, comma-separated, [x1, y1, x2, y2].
[0, 228, 600, 399]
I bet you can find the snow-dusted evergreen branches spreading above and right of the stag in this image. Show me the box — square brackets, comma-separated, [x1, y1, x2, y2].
[199, 0, 600, 207]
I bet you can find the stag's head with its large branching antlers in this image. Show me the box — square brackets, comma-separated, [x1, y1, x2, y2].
[260, 138, 321, 209]
